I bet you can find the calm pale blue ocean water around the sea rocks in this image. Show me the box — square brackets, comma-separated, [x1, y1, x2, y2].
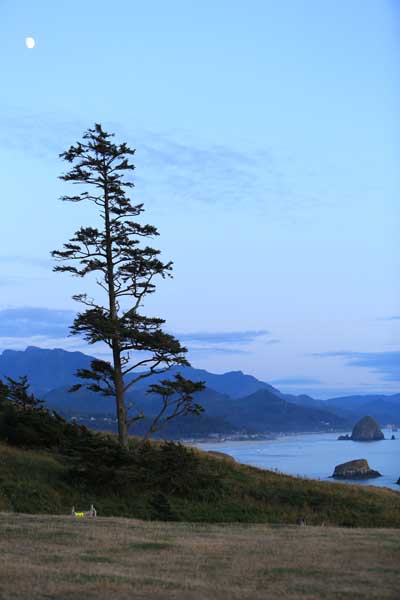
[198, 429, 400, 492]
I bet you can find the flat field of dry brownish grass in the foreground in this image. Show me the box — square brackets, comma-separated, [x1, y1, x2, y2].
[0, 513, 400, 600]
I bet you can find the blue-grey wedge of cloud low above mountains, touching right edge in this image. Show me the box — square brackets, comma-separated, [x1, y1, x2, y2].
[312, 351, 400, 381]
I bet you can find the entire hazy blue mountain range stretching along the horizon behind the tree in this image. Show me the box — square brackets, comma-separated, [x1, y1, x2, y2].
[0, 346, 400, 435]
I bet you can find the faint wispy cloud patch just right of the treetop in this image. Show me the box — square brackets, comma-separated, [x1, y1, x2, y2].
[135, 133, 291, 211]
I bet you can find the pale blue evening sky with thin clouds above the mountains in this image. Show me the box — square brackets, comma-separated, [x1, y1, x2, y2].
[0, 0, 400, 398]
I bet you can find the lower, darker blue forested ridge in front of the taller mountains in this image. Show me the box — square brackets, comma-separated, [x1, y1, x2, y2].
[45, 388, 351, 437]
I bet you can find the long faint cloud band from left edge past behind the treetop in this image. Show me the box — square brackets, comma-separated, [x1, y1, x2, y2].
[0, 114, 308, 210]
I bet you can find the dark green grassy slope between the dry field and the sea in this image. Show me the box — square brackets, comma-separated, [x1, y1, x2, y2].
[0, 436, 400, 527]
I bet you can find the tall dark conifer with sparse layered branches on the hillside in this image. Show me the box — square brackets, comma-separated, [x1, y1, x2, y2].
[52, 124, 201, 446]
